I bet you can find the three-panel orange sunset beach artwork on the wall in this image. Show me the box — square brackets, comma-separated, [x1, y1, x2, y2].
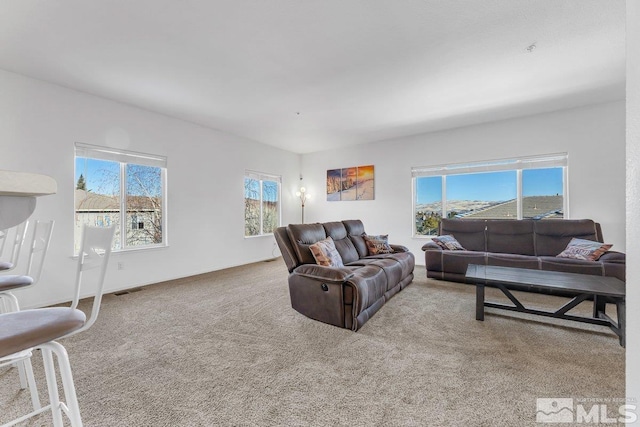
[327, 165, 374, 202]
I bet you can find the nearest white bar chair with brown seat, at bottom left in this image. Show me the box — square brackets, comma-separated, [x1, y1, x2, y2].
[0, 226, 114, 427]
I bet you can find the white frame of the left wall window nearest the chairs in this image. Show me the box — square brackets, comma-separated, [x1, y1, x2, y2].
[73, 142, 169, 252]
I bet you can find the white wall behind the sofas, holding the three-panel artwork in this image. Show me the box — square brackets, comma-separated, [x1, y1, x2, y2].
[302, 101, 625, 265]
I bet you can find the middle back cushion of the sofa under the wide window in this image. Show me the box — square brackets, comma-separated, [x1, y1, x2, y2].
[487, 219, 535, 255]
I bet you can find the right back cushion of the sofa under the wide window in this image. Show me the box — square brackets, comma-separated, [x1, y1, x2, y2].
[533, 219, 599, 256]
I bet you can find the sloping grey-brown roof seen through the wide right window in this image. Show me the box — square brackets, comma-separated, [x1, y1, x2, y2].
[459, 196, 563, 219]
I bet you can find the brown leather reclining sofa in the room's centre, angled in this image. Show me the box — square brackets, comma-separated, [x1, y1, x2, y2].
[275, 220, 415, 331]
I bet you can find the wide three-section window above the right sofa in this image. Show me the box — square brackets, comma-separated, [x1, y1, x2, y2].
[411, 154, 567, 236]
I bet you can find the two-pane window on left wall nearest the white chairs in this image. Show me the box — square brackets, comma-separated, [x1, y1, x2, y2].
[74, 143, 167, 254]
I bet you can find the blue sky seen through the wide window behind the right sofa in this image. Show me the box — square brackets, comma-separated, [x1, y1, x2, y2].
[416, 168, 563, 204]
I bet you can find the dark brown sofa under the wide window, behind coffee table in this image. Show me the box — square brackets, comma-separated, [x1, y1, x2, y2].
[422, 219, 625, 282]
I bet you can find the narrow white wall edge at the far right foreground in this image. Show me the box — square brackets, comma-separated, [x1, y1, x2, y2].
[627, 0, 640, 418]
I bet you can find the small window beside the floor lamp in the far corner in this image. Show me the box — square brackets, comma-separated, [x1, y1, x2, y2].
[244, 171, 282, 237]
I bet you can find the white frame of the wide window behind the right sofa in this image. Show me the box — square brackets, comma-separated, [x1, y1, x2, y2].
[411, 153, 569, 239]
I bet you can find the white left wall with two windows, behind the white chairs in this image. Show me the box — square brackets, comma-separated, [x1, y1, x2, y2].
[0, 71, 300, 307]
